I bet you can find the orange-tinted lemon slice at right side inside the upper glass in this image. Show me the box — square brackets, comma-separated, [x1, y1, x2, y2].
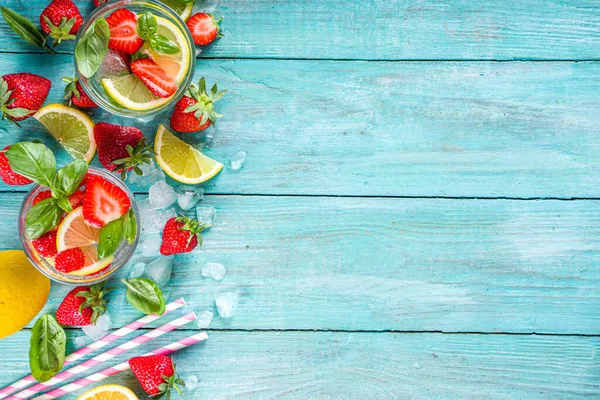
[141, 15, 190, 83]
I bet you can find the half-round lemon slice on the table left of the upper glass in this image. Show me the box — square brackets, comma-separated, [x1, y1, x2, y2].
[33, 104, 96, 163]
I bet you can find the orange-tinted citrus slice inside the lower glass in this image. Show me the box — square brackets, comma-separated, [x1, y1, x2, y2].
[56, 207, 100, 252]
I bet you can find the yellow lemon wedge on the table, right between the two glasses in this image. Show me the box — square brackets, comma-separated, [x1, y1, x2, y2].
[154, 125, 223, 185]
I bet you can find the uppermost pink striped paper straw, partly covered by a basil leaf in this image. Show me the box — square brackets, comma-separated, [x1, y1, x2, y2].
[0, 297, 185, 399]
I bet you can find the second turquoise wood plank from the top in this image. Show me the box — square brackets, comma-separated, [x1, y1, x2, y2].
[0, 54, 600, 198]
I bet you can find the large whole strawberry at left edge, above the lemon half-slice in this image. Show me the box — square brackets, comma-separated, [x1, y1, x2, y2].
[0, 72, 52, 125]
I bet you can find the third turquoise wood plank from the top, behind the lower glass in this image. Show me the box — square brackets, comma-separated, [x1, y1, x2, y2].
[0, 194, 600, 334]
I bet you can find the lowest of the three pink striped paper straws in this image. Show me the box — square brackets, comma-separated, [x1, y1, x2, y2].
[34, 332, 208, 400]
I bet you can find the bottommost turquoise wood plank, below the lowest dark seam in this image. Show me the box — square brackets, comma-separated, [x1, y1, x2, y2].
[0, 332, 600, 399]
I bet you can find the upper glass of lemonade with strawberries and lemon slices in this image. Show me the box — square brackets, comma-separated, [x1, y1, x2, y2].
[74, 0, 196, 119]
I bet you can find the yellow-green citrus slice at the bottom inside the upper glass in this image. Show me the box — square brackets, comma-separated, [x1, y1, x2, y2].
[101, 74, 170, 110]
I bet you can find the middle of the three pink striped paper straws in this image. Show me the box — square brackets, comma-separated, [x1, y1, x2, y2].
[8, 312, 196, 400]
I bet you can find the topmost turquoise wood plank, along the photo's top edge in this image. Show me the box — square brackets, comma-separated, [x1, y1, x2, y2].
[0, 0, 600, 60]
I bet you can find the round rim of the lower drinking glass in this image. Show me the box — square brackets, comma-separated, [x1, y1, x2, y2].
[18, 168, 141, 286]
